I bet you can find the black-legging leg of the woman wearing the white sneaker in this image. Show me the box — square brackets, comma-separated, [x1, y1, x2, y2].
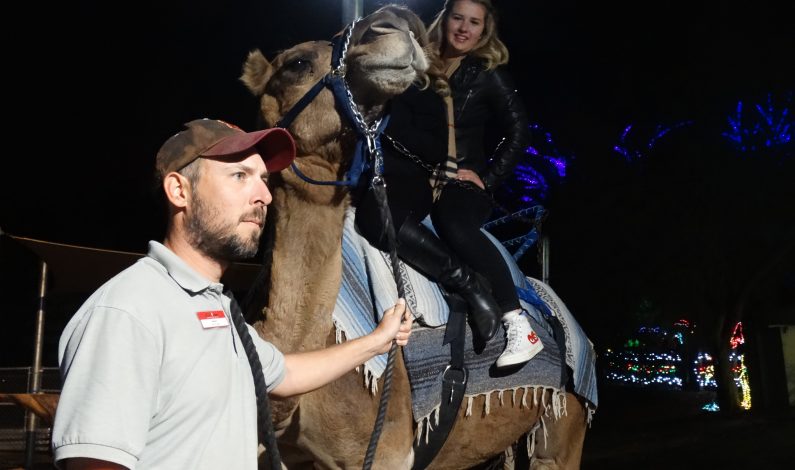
[431, 183, 521, 313]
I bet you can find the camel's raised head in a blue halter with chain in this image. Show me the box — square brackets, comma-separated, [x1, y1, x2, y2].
[241, 6, 428, 169]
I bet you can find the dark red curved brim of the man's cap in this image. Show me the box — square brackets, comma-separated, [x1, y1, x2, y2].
[202, 127, 295, 173]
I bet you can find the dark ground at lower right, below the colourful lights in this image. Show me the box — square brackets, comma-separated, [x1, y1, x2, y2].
[581, 387, 795, 470]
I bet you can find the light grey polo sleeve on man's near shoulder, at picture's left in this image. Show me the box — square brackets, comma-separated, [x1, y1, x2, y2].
[52, 307, 162, 468]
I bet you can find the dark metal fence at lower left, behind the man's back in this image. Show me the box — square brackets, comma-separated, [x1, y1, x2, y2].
[0, 367, 61, 470]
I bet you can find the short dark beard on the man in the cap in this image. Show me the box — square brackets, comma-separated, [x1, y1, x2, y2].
[185, 192, 265, 261]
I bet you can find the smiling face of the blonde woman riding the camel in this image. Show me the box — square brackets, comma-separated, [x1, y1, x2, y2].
[442, 0, 486, 59]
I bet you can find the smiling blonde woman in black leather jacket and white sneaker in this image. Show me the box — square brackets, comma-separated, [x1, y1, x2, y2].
[428, 0, 543, 367]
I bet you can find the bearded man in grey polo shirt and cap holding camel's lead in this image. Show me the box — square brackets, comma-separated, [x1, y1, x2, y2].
[52, 119, 411, 470]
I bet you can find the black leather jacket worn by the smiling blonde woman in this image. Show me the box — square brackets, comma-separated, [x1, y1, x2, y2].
[450, 56, 531, 192]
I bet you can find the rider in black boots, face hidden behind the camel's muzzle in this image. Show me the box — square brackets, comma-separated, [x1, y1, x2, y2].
[354, 5, 500, 341]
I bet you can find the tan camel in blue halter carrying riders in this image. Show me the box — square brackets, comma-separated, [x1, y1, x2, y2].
[241, 4, 589, 469]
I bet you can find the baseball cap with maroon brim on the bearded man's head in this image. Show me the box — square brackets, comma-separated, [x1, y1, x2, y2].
[155, 119, 295, 179]
